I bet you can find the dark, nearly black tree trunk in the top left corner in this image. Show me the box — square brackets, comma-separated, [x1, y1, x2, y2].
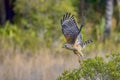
[0, 0, 15, 25]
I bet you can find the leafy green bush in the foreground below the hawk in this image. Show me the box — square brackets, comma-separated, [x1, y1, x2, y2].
[57, 54, 120, 80]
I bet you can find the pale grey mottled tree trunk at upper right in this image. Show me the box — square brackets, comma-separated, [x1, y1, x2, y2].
[104, 0, 113, 41]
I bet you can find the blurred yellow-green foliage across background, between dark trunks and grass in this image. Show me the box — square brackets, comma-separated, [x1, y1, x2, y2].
[0, 0, 120, 53]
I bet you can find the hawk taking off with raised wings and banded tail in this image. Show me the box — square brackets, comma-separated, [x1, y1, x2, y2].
[61, 13, 93, 62]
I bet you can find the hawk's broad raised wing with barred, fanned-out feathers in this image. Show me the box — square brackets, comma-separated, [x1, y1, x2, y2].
[61, 13, 80, 44]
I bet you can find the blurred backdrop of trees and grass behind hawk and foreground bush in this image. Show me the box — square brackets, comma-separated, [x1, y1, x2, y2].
[0, 0, 120, 80]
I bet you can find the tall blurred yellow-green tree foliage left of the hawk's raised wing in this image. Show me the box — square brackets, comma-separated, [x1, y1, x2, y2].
[14, 0, 76, 46]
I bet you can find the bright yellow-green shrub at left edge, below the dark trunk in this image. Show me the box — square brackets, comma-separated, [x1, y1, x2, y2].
[0, 22, 40, 50]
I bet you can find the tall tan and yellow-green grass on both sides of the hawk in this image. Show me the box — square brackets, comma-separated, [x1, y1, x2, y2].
[0, 31, 120, 80]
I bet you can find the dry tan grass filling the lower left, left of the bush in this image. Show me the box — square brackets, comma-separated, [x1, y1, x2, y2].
[0, 49, 78, 80]
